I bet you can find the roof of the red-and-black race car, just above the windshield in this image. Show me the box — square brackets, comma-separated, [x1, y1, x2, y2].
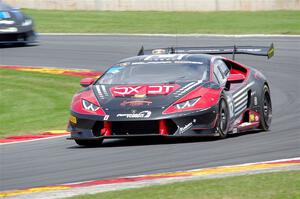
[119, 54, 215, 63]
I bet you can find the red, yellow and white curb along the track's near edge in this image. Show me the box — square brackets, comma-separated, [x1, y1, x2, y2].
[0, 157, 300, 199]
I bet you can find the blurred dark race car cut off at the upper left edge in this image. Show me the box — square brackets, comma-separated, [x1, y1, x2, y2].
[0, 0, 36, 44]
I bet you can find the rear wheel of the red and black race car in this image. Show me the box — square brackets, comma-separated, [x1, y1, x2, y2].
[259, 85, 272, 131]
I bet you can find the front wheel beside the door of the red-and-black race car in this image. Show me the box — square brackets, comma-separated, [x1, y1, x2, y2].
[217, 96, 229, 139]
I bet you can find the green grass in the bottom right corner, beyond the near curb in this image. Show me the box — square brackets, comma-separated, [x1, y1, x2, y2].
[68, 171, 300, 199]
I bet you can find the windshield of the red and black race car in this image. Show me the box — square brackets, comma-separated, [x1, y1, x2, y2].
[97, 60, 209, 84]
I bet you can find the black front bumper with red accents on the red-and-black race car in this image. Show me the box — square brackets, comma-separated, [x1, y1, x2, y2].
[68, 106, 217, 140]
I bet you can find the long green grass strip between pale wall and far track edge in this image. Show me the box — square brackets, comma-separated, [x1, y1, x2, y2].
[24, 9, 300, 34]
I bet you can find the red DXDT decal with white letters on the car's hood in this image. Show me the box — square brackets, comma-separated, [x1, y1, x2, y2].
[110, 84, 179, 97]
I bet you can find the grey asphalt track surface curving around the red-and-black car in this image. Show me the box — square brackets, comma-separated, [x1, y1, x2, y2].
[0, 36, 300, 190]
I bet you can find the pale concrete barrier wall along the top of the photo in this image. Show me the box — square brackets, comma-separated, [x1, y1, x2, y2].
[0, 0, 300, 11]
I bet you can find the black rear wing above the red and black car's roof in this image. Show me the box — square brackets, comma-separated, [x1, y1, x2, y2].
[138, 43, 274, 59]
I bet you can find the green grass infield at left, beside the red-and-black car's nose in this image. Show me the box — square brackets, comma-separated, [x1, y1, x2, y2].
[0, 69, 80, 137]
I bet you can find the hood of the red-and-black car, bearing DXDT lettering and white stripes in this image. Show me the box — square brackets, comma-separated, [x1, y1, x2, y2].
[91, 81, 204, 119]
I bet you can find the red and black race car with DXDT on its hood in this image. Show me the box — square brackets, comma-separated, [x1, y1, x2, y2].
[68, 44, 274, 146]
